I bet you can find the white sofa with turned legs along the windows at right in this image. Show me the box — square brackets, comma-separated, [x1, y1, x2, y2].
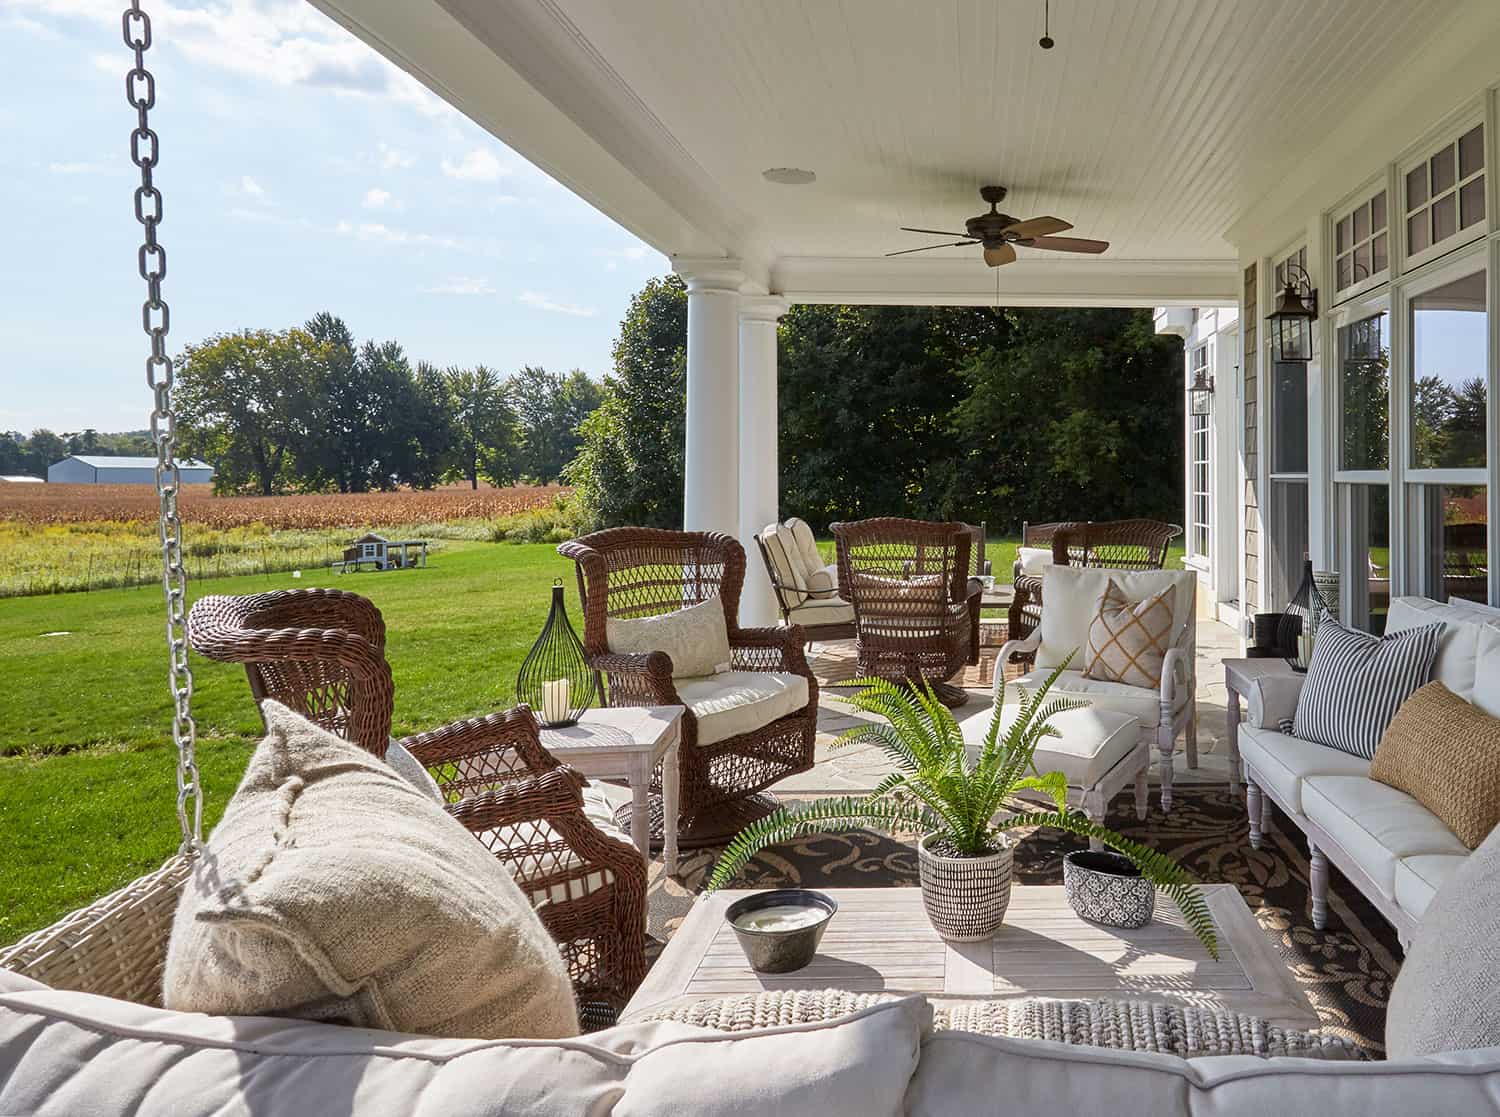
[1239, 597, 1500, 946]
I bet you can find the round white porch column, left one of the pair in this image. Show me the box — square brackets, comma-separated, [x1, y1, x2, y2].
[675, 259, 744, 535]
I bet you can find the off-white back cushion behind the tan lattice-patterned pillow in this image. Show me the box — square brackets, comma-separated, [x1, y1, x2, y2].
[1037, 567, 1199, 670]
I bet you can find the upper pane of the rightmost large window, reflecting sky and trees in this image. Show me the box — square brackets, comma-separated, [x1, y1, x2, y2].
[1409, 271, 1488, 469]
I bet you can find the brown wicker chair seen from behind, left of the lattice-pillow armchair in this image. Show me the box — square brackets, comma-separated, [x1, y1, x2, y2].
[833, 517, 981, 706]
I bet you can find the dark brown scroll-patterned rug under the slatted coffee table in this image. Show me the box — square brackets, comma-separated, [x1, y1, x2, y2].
[648, 784, 1401, 1056]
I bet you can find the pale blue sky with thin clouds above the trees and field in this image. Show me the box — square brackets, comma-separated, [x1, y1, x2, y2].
[0, 0, 668, 432]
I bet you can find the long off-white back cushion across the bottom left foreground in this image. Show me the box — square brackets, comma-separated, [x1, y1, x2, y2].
[0, 983, 932, 1117]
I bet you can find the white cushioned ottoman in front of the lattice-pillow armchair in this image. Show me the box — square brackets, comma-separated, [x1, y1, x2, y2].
[963, 705, 1151, 823]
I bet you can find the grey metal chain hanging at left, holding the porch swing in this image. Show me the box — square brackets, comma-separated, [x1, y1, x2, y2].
[122, 0, 203, 852]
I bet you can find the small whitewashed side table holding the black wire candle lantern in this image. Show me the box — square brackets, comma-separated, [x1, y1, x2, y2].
[542, 706, 683, 874]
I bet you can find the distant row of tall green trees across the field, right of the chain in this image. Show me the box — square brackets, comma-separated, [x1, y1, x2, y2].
[177, 312, 602, 495]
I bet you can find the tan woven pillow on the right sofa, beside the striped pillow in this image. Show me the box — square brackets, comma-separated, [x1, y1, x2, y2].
[1370, 682, 1500, 849]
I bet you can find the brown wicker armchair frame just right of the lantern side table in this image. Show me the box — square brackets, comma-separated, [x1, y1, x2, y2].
[558, 528, 818, 847]
